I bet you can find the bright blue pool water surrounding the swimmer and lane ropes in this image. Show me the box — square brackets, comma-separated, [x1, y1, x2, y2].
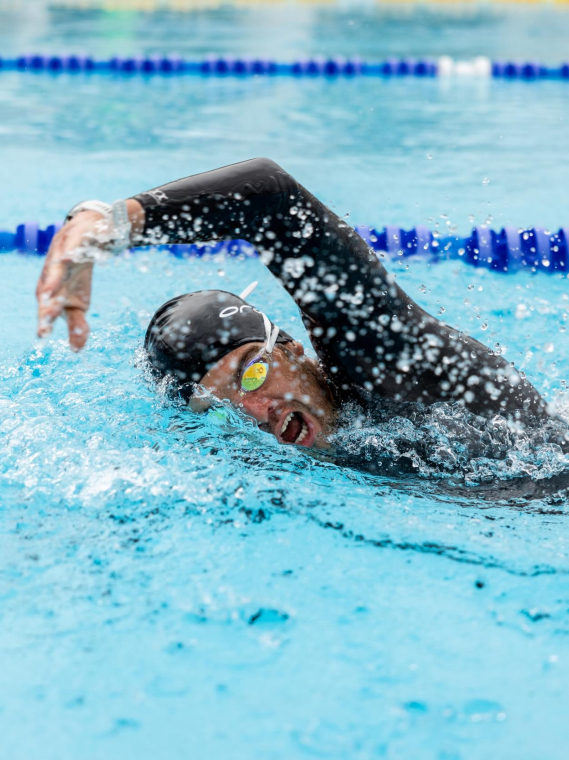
[0, 4, 569, 760]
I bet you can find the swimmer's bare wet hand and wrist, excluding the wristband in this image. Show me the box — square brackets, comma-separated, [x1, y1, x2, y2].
[36, 199, 144, 351]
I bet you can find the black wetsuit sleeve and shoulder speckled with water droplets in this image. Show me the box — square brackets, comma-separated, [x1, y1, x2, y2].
[131, 159, 543, 413]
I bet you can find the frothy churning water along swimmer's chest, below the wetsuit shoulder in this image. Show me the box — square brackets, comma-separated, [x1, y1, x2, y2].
[335, 394, 569, 492]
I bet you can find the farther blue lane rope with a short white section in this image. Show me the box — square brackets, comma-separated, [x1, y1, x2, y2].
[0, 55, 569, 81]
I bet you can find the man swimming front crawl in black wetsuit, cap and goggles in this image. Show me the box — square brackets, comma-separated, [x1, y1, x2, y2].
[37, 158, 546, 448]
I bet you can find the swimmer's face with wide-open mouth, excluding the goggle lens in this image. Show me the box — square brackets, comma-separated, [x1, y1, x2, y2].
[191, 341, 335, 448]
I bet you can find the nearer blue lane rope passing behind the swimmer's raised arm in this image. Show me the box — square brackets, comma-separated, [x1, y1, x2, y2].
[4, 222, 569, 273]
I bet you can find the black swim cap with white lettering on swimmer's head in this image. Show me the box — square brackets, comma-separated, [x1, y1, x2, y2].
[144, 290, 292, 387]
